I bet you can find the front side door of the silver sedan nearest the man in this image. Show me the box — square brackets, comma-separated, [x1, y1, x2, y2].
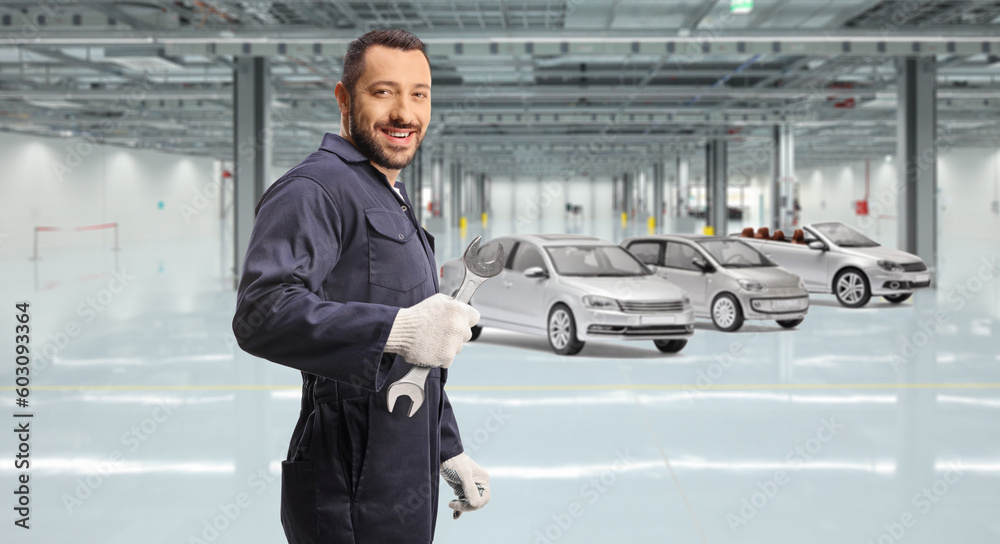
[497, 241, 554, 329]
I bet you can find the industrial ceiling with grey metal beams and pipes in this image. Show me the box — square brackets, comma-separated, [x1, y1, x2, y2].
[0, 0, 1000, 175]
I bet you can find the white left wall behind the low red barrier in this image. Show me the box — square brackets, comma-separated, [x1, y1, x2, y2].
[0, 133, 220, 256]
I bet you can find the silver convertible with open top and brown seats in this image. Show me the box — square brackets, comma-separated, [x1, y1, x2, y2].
[734, 222, 931, 308]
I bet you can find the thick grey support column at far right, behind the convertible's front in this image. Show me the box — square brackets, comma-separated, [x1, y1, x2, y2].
[896, 57, 937, 270]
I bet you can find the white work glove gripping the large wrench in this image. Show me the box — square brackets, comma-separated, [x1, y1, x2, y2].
[385, 293, 479, 368]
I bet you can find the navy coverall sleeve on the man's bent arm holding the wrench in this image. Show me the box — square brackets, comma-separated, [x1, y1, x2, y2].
[233, 178, 399, 391]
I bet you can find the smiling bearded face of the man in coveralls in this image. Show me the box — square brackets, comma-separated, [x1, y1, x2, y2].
[335, 45, 431, 176]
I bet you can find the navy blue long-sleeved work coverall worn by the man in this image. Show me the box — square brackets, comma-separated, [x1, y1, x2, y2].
[233, 133, 463, 544]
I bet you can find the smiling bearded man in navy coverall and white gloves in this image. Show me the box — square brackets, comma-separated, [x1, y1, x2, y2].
[233, 30, 490, 544]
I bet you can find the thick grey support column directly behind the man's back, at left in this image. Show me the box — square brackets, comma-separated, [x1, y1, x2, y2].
[233, 57, 271, 289]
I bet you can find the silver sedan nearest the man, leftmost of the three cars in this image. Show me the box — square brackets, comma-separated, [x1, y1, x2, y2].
[440, 234, 694, 355]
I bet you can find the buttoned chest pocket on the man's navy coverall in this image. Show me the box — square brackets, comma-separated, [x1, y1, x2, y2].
[365, 208, 429, 292]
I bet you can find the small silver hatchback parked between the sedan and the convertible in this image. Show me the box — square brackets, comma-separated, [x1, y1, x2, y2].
[622, 234, 809, 332]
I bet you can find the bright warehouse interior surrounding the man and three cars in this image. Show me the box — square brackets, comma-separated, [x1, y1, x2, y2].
[0, 0, 1000, 544]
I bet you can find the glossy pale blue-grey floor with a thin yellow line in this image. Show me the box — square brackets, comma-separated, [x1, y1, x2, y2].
[0, 222, 1000, 544]
